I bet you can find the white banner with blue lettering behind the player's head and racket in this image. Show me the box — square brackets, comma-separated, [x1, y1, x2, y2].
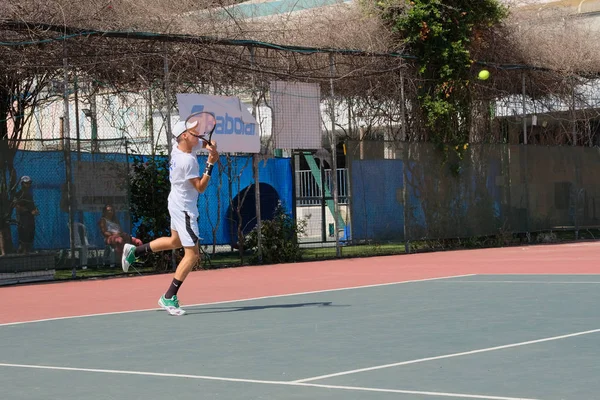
[177, 94, 260, 153]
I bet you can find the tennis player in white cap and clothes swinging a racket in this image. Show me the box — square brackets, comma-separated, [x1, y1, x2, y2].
[121, 117, 219, 316]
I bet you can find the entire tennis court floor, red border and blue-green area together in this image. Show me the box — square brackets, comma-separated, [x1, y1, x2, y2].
[0, 242, 600, 400]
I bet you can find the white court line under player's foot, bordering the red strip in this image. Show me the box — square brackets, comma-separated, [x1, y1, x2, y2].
[0, 274, 476, 327]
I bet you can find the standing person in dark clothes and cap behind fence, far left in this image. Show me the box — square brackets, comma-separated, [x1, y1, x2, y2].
[13, 176, 40, 254]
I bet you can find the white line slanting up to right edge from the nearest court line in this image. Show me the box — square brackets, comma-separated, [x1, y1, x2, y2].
[293, 329, 600, 383]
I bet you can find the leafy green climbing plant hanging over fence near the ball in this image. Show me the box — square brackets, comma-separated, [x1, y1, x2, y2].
[377, 0, 507, 157]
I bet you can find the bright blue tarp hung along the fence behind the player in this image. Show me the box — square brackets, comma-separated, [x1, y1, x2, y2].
[12, 151, 293, 250]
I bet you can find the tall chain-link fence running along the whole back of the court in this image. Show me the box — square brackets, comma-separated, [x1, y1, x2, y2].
[0, 18, 600, 278]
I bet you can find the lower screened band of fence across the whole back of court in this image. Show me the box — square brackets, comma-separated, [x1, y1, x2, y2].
[0, 139, 600, 282]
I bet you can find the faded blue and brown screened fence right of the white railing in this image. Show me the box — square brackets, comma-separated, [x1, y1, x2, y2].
[348, 141, 600, 242]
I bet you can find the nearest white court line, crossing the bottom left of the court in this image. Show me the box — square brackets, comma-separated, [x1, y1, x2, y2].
[0, 363, 538, 400]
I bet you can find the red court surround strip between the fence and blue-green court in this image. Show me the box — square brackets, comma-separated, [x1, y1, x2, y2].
[0, 242, 600, 324]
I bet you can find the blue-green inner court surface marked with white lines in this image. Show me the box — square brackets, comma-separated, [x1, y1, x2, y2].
[0, 275, 600, 400]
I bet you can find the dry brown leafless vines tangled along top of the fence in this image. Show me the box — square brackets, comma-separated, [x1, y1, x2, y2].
[0, 0, 600, 145]
